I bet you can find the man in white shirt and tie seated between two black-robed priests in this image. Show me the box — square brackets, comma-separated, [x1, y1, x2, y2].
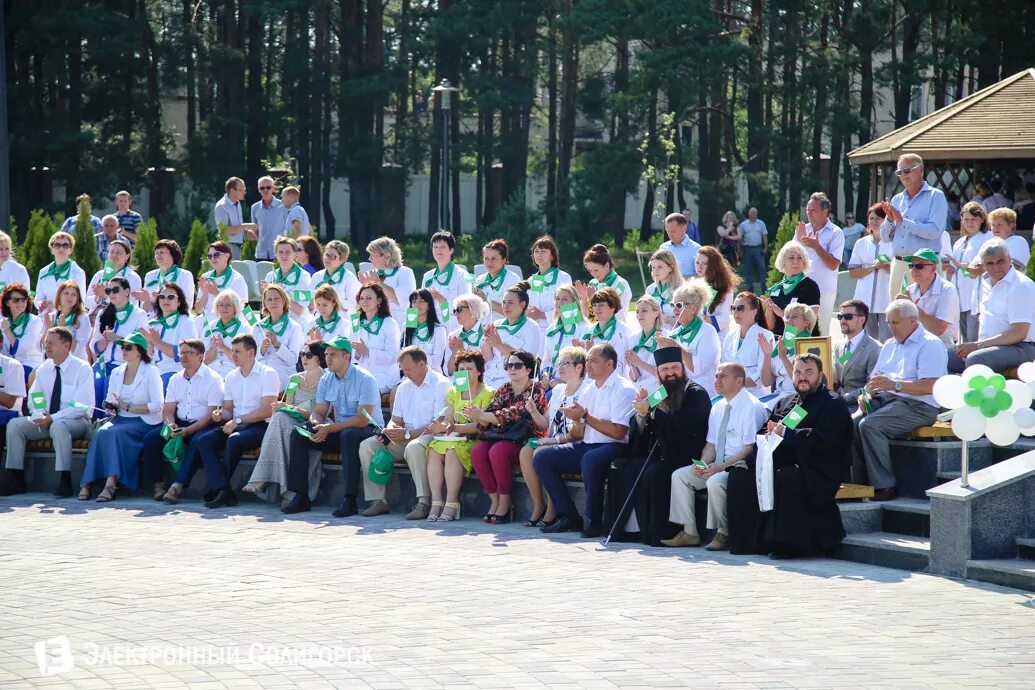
[661, 362, 769, 551]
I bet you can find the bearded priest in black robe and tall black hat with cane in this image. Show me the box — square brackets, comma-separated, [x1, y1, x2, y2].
[609, 347, 711, 546]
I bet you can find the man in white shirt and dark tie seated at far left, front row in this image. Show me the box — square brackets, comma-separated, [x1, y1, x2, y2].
[0, 327, 93, 499]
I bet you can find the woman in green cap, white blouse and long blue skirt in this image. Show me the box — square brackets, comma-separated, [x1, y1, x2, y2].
[79, 331, 165, 503]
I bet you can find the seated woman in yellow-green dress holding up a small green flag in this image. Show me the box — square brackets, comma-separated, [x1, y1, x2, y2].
[427, 351, 495, 522]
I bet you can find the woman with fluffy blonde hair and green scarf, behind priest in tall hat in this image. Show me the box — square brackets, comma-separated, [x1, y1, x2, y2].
[657, 278, 722, 397]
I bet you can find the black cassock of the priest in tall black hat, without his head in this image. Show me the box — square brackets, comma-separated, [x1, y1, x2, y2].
[608, 382, 711, 546]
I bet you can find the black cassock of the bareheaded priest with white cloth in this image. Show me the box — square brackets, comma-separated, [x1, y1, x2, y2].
[727, 384, 853, 556]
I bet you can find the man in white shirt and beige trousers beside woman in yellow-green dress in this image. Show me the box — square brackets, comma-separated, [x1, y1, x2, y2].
[359, 346, 452, 520]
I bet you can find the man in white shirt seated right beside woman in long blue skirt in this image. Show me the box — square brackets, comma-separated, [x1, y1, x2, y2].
[141, 338, 224, 503]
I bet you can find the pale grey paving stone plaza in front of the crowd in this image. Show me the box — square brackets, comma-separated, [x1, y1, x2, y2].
[0, 494, 1035, 690]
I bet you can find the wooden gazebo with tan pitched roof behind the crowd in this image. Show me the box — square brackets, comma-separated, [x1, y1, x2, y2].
[848, 68, 1035, 202]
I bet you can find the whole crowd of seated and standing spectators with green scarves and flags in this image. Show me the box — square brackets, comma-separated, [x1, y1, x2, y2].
[0, 154, 1035, 557]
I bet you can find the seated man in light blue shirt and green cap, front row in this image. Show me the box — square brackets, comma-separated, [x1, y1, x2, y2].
[282, 335, 384, 517]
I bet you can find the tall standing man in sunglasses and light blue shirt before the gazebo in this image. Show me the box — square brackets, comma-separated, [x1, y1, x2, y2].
[881, 153, 949, 299]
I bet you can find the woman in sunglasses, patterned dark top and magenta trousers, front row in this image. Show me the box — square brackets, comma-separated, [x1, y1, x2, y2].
[464, 351, 546, 524]
